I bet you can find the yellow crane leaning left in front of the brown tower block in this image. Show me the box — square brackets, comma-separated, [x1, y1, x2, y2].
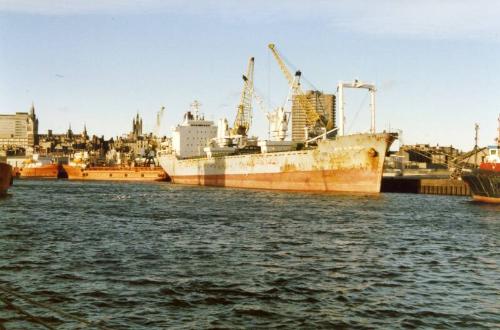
[269, 44, 333, 133]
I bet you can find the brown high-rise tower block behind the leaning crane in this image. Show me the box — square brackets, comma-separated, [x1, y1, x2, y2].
[292, 91, 335, 141]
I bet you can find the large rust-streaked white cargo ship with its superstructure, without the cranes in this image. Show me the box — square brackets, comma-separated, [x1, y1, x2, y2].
[158, 96, 397, 193]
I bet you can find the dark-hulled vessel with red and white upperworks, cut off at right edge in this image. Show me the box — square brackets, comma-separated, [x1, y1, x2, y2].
[462, 116, 500, 203]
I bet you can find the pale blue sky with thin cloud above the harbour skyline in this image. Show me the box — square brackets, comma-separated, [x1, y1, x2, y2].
[0, 0, 500, 149]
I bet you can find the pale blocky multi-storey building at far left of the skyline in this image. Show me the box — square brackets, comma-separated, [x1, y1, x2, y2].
[0, 105, 38, 150]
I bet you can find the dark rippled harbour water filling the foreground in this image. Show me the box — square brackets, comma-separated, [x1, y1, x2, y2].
[0, 180, 500, 329]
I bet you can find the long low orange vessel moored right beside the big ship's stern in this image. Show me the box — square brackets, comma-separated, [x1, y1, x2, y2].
[63, 165, 168, 181]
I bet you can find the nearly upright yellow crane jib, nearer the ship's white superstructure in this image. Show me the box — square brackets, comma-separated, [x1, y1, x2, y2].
[232, 57, 254, 136]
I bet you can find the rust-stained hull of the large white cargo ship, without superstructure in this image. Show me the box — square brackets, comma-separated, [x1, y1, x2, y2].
[159, 133, 395, 193]
